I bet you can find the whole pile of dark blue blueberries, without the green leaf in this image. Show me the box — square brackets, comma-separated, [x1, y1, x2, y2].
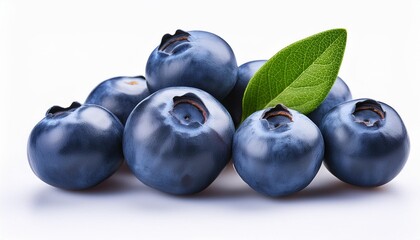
[27, 30, 410, 197]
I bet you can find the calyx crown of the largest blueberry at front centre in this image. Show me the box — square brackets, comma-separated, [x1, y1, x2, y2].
[170, 93, 209, 127]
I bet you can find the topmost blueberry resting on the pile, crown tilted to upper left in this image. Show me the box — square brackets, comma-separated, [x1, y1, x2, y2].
[146, 30, 238, 100]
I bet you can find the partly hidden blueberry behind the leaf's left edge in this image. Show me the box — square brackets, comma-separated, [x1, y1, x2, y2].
[222, 60, 267, 127]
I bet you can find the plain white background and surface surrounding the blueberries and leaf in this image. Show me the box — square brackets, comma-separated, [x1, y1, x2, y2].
[0, 0, 420, 239]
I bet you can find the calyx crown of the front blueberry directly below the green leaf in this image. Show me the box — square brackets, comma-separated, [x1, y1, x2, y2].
[261, 104, 293, 130]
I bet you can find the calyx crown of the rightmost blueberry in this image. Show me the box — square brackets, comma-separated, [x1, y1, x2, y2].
[352, 99, 386, 127]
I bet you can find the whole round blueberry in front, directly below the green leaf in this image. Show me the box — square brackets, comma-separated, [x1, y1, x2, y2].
[232, 105, 324, 197]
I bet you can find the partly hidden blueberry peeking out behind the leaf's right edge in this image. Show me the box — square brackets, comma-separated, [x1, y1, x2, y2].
[308, 77, 352, 126]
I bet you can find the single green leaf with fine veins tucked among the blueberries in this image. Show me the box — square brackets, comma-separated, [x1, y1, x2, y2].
[242, 29, 347, 120]
